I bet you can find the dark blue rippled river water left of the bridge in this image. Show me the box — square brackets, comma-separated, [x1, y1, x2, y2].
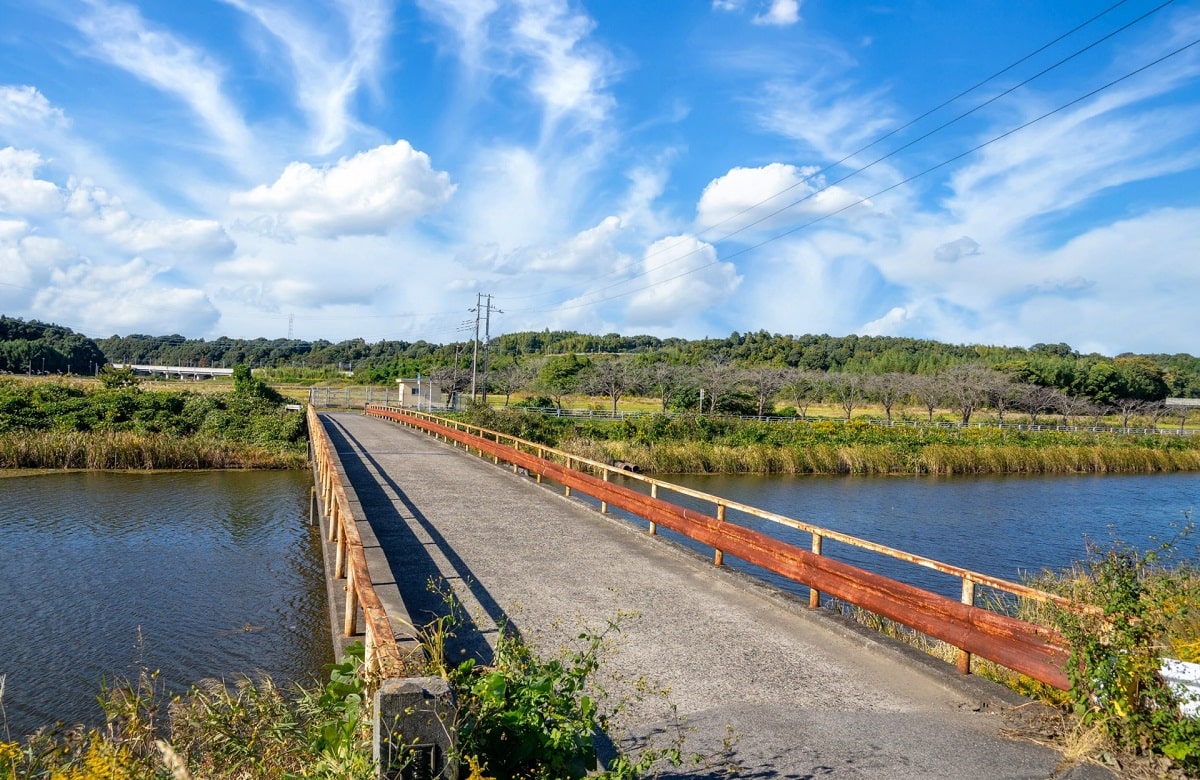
[0, 472, 332, 739]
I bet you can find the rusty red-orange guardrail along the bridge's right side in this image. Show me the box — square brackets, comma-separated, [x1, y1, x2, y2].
[366, 406, 1070, 690]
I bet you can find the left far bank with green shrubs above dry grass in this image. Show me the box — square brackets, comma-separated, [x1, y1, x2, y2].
[0, 379, 306, 469]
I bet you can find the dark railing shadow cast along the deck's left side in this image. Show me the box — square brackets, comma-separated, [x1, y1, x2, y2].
[324, 418, 520, 664]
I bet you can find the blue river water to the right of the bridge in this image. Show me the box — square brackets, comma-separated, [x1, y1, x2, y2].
[631, 474, 1200, 599]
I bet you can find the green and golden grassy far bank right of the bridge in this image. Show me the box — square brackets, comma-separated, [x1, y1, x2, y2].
[458, 409, 1200, 475]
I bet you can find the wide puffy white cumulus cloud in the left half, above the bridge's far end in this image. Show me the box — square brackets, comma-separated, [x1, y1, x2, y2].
[229, 140, 455, 238]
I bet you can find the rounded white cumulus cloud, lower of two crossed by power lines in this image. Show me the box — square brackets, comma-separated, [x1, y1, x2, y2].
[625, 235, 742, 326]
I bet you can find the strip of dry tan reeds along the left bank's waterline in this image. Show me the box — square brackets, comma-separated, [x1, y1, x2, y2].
[0, 431, 306, 469]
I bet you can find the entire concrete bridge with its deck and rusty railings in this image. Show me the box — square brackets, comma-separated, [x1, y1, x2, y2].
[308, 407, 1108, 779]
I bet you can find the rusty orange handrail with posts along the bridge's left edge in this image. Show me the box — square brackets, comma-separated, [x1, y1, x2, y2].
[307, 404, 403, 679]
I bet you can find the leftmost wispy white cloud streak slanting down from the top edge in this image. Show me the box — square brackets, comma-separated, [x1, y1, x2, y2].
[73, 1, 251, 150]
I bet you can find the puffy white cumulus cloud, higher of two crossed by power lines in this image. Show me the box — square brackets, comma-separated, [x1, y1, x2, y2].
[696, 162, 870, 235]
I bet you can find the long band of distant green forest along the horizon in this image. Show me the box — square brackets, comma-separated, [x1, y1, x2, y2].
[0, 316, 1200, 400]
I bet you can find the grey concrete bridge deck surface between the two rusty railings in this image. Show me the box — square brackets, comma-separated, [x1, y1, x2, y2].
[322, 414, 1111, 780]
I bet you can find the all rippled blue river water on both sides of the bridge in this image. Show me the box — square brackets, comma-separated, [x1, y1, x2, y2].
[0, 472, 1200, 739]
